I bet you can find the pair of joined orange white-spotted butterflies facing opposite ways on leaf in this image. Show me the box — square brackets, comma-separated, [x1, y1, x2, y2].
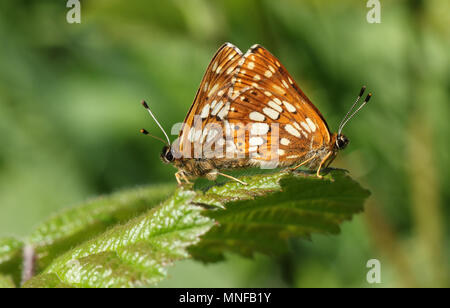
[141, 43, 372, 185]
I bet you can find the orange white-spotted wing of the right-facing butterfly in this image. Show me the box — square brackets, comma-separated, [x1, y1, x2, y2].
[224, 45, 331, 165]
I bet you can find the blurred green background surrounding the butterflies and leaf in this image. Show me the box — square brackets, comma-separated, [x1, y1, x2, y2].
[0, 0, 450, 287]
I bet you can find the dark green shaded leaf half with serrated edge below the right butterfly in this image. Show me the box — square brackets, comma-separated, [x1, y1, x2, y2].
[189, 170, 370, 262]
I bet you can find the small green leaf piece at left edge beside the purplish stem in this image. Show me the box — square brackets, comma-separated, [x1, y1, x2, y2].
[0, 238, 23, 285]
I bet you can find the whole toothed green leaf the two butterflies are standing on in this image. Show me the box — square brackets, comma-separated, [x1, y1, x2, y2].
[12, 170, 370, 287]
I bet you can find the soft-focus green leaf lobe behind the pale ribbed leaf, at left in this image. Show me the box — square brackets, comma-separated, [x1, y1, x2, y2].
[27, 184, 175, 272]
